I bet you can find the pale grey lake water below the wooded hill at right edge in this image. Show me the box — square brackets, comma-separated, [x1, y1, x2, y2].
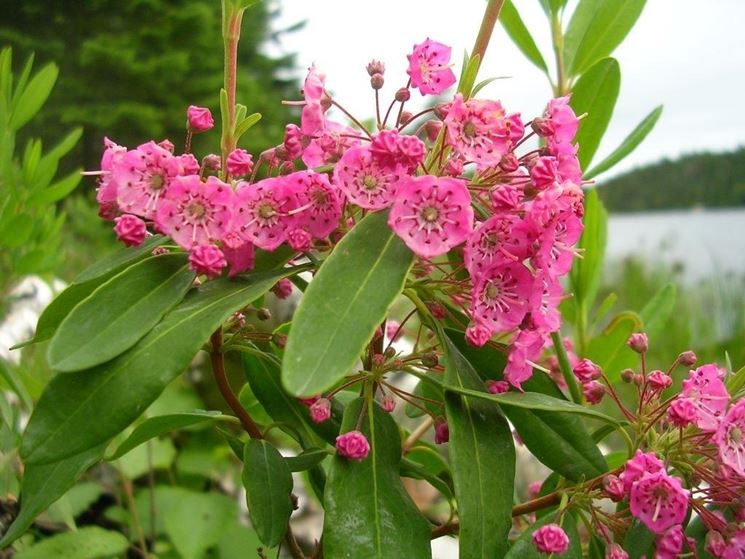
[607, 208, 745, 282]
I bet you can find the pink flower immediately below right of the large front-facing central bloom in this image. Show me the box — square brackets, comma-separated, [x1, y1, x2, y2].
[463, 212, 532, 279]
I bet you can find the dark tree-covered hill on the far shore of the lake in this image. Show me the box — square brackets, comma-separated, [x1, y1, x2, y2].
[598, 147, 745, 212]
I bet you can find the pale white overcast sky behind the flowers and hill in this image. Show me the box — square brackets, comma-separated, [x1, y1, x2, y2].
[274, 0, 745, 178]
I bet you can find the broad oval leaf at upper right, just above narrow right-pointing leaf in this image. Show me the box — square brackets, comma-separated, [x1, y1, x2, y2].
[570, 58, 621, 169]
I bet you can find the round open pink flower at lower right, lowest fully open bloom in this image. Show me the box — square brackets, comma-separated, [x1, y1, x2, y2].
[624, 471, 689, 534]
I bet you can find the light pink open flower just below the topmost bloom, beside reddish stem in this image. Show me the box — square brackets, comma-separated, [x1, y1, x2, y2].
[445, 93, 512, 168]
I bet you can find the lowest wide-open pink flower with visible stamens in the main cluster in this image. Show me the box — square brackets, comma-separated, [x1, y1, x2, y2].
[471, 263, 533, 331]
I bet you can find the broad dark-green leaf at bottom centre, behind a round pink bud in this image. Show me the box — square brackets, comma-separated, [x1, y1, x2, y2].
[323, 398, 431, 559]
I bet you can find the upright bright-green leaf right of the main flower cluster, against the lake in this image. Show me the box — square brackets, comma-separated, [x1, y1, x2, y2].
[569, 188, 608, 327]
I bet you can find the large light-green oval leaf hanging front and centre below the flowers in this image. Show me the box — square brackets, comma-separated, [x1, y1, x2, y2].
[282, 212, 414, 397]
